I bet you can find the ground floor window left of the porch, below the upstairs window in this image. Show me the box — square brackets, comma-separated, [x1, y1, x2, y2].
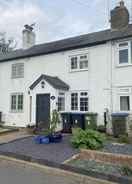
[11, 93, 23, 112]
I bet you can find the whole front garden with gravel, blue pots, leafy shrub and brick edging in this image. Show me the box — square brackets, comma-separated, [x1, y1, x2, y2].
[3, 111, 132, 182]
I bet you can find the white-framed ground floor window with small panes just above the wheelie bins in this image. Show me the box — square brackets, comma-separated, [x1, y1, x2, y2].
[71, 92, 88, 111]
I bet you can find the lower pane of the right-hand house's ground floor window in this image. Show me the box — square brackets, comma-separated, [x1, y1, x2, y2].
[120, 96, 130, 111]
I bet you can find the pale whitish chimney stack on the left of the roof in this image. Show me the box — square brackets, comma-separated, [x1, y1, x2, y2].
[22, 24, 36, 49]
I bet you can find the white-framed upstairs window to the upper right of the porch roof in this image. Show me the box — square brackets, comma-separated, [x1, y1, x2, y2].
[70, 54, 88, 71]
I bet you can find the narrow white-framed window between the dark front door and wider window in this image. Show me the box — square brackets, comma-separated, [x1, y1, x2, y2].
[58, 93, 65, 111]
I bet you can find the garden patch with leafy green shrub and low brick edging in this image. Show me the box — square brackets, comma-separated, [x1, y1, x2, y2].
[67, 128, 132, 181]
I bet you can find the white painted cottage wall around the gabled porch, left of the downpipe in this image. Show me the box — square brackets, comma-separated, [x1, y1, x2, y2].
[0, 43, 111, 126]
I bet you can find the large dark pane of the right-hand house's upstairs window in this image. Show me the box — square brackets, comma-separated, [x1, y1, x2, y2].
[119, 49, 128, 64]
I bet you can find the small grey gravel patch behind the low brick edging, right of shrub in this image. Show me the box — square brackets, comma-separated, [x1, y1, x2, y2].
[103, 142, 132, 156]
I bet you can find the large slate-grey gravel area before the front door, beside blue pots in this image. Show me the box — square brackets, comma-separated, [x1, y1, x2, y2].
[0, 135, 78, 163]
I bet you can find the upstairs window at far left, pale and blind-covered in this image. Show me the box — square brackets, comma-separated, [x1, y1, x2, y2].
[12, 63, 24, 79]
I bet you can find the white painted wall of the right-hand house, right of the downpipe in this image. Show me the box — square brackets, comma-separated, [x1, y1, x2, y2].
[112, 38, 132, 113]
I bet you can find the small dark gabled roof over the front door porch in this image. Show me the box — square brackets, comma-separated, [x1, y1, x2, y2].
[29, 74, 69, 90]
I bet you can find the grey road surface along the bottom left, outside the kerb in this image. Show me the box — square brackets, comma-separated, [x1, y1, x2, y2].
[0, 159, 116, 184]
